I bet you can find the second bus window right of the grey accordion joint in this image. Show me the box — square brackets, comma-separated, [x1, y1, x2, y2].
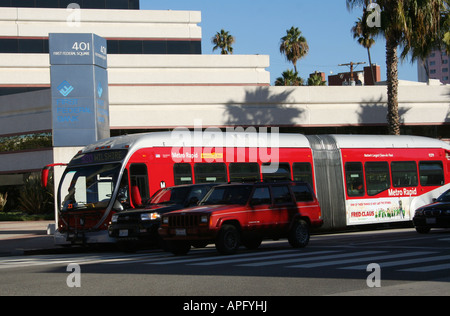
[365, 162, 391, 196]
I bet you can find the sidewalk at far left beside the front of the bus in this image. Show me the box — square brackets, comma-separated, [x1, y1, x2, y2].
[0, 221, 55, 257]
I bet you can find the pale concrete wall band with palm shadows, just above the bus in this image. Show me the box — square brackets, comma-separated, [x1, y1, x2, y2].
[110, 86, 450, 129]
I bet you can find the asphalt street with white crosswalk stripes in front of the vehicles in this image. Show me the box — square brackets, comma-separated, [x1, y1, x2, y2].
[0, 228, 450, 296]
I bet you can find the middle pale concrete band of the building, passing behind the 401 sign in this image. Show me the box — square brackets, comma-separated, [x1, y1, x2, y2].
[0, 54, 270, 87]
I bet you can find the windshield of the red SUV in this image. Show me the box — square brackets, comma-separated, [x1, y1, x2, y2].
[200, 185, 253, 205]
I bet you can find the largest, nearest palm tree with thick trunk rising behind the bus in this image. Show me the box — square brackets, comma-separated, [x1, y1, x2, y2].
[346, 0, 442, 135]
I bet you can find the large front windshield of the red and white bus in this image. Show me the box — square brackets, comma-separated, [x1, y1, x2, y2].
[58, 163, 121, 211]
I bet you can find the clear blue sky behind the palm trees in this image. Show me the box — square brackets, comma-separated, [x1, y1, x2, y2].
[140, 0, 417, 84]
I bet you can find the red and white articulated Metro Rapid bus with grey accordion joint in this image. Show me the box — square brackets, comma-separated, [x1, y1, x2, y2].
[43, 131, 450, 245]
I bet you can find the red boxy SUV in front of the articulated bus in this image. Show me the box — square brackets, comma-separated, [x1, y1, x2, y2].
[159, 182, 323, 255]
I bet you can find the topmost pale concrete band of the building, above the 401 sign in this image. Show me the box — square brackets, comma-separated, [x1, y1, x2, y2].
[0, 8, 202, 40]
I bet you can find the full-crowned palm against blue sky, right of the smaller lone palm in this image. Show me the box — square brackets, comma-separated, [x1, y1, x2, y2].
[280, 27, 309, 72]
